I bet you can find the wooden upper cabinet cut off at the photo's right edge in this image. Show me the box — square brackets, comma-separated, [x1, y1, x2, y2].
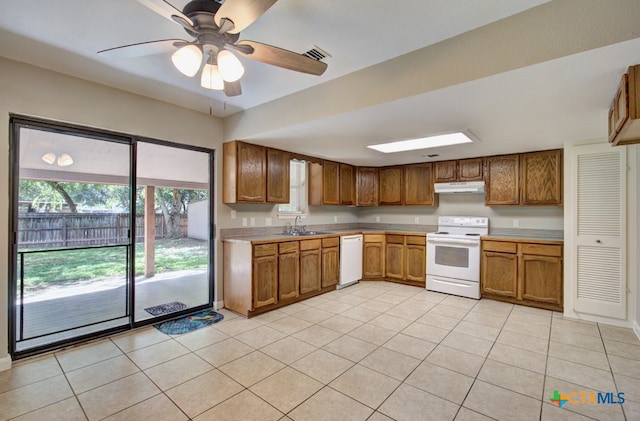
[609, 64, 640, 146]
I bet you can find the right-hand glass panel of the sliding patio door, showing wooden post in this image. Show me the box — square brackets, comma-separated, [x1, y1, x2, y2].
[134, 142, 211, 322]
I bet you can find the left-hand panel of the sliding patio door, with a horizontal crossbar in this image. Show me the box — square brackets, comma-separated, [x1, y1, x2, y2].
[12, 123, 131, 352]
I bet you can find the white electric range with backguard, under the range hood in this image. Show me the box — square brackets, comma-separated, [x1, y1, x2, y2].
[427, 216, 489, 300]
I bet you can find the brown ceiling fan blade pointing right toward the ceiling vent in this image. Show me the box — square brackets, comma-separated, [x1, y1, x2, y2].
[228, 41, 327, 76]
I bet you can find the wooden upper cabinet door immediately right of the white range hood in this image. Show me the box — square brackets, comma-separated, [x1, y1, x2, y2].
[484, 155, 520, 206]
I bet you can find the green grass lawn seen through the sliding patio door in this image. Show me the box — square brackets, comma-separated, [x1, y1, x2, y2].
[19, 238, 209, 288]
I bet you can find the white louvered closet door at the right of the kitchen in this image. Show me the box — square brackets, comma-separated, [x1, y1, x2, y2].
[573, 144, 626, 319]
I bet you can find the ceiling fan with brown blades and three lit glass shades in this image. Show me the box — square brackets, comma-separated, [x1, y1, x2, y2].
[98, 0, 327, 96]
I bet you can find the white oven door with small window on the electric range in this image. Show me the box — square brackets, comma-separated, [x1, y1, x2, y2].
[427, 236, 480, 282]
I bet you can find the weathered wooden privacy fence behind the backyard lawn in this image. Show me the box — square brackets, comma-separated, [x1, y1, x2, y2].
[18, 213, 187, 249]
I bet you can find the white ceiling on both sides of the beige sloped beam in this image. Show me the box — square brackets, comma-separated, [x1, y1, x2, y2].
[0, 0, 640, 165]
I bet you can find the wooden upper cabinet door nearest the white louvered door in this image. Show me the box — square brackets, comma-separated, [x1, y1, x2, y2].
[520, 149, 562, 206]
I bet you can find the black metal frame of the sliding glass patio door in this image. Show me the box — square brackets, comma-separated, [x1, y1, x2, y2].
[7, 113, 216, 359]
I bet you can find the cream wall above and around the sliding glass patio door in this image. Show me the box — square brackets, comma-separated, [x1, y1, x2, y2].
[0, 58, 222, 369]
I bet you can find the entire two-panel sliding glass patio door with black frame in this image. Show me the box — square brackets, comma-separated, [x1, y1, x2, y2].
[10, 117, 213, 357]
